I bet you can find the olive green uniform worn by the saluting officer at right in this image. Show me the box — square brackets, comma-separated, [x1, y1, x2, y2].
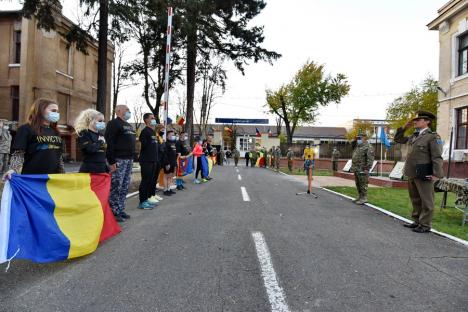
[395, 128, 444, 228]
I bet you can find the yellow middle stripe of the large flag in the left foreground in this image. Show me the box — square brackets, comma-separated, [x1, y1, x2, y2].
[47, 173, 104, 259]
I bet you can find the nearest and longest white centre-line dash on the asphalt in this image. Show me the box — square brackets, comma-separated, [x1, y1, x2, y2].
[252, 232, 289, 312]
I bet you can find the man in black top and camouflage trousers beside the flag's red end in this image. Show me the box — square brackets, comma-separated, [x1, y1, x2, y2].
[104, 105, 136, 222]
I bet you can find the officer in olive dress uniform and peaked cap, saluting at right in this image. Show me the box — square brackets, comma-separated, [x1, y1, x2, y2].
[395, 111, 444, 233]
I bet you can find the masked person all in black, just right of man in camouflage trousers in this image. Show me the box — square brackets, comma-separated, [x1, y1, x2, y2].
[138, 113, 160, 210]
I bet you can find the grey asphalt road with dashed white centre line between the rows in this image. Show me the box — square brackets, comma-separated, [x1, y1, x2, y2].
[0, 167, 468, 312]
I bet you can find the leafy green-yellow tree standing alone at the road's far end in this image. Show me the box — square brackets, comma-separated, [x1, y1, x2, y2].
[266, 61, 350, 146]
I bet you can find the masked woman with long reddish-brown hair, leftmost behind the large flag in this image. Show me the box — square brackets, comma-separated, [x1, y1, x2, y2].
[3, 99, 65, 180]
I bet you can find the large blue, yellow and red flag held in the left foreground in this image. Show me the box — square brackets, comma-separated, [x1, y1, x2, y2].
[0, 173, 121, 263]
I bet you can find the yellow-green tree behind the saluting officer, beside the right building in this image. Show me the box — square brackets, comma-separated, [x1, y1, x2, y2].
[387, 76, 439, 131]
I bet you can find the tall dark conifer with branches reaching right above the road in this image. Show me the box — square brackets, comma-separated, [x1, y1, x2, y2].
[173, 0, 281, 141]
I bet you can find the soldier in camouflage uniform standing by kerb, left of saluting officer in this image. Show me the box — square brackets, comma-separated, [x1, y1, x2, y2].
[351, 133, 374, 205]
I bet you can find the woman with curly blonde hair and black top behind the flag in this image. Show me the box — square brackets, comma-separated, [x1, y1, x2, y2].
[75, 109, 109, 173]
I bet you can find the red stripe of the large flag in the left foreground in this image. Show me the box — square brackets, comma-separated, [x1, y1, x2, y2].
[90, 173, 122, 243]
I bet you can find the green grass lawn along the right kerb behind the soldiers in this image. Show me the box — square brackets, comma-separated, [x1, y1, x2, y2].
[327, 186, 468, 240]
